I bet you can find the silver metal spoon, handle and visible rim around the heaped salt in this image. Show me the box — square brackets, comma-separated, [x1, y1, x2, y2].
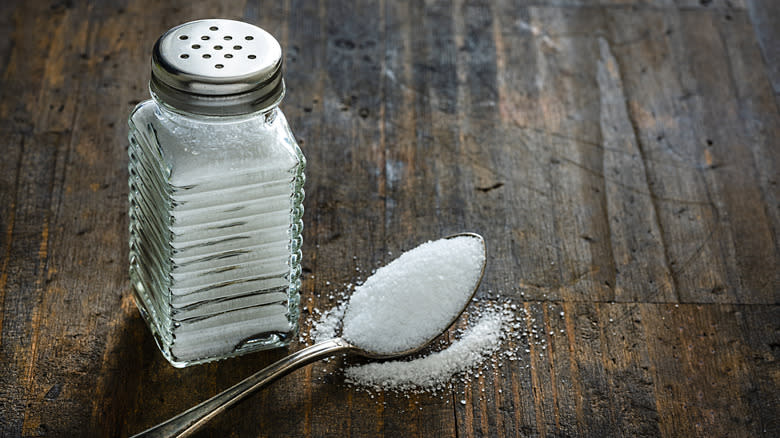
[132, 233, 487, 438]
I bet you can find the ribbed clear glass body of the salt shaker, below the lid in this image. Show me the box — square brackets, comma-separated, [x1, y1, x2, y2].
[129, 99, 306, 367]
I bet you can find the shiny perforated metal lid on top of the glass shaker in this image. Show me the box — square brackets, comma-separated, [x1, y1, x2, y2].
[149, 19, 284, 115]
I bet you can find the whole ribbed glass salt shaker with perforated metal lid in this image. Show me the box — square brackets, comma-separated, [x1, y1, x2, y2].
[129, 19, 306, 367]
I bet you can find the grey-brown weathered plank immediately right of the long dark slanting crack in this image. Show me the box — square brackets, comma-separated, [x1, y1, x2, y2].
[610, 11, 735, 302]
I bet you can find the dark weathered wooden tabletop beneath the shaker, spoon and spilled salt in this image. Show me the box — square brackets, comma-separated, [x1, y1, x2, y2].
[0, 0, 780, 437]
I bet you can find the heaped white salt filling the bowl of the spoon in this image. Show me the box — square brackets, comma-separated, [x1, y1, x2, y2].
[342, 235, 485, 354]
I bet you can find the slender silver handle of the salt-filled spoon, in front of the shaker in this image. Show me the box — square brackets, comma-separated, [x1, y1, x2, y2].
[132, 338, 354, 438]
